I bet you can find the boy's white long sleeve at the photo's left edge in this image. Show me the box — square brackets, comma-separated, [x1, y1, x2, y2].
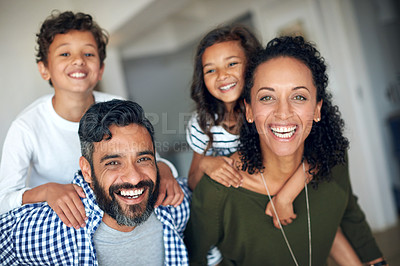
[0, 121, 33, 213]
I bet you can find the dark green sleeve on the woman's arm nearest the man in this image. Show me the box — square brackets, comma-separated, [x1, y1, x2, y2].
[184, 175, 226, 265]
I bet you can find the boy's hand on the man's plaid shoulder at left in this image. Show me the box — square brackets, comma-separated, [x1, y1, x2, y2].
[46, 183, 87, 229]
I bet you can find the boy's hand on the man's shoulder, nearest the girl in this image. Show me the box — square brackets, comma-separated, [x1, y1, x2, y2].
[155, 162, 184, 207]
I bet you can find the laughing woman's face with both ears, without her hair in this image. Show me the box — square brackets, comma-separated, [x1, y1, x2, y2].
[246, 57, 322, 156]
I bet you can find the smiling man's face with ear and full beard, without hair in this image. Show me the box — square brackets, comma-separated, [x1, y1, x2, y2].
[81, 124, 158, 227]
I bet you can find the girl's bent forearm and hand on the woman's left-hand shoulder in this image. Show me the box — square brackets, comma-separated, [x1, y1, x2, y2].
[188, 152, 243, 191]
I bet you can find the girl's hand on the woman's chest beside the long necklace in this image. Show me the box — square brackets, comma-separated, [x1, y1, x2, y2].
[265, 194, 297, 229]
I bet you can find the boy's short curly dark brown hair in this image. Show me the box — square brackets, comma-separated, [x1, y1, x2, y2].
[36, 11, 108, 67]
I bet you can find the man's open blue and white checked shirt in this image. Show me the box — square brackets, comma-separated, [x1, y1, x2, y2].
[0, 173, 191, 265]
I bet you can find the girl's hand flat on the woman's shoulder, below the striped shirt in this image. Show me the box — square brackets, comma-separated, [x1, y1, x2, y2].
[202, 156, 243, 188]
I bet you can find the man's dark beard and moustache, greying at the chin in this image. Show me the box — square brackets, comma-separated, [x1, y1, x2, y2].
[92, 170, 160, 227]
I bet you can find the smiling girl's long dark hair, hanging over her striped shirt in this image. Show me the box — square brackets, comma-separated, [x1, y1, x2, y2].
[191, 25, 262, 153]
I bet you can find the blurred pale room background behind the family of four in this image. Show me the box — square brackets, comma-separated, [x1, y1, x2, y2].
[0, 0, 400, 256]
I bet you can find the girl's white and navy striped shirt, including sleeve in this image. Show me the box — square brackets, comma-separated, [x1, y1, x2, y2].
[186, 113, 239, 156]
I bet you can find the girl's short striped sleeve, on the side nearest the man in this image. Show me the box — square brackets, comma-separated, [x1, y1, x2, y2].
[186, 114, 209, 154]
